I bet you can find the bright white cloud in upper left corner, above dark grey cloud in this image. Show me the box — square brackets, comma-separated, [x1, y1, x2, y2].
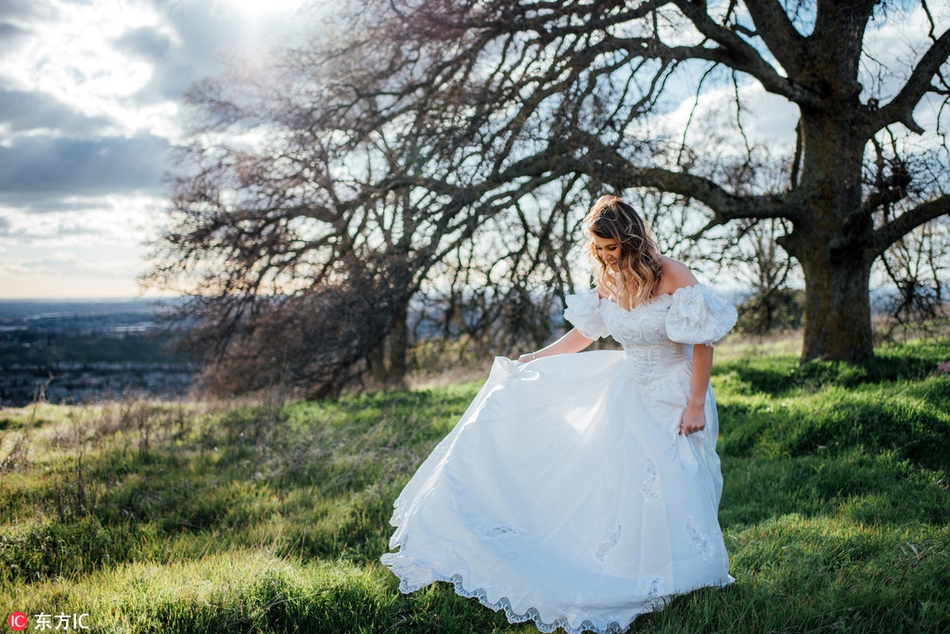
[0, 0, 177, 139]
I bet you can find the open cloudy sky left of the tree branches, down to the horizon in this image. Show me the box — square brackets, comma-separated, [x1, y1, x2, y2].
[0, 0, 320, 299]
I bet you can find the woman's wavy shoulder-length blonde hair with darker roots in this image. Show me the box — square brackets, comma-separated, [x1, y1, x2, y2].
[584, 195, 662, 307]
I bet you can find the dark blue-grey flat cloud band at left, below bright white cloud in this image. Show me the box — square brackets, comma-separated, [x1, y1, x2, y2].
[0, 135, 170, 198]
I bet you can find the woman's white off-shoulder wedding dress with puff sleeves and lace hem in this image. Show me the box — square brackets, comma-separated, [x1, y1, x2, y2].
[382, 285, 736, 633]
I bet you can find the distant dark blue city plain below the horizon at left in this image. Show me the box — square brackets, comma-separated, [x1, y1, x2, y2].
[0, 299, 195, 407]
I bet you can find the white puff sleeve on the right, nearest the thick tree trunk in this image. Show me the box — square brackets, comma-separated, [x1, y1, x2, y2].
[666, 284, 738, 346]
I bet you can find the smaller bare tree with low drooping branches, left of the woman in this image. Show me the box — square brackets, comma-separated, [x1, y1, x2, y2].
[145, 40, 592, 396]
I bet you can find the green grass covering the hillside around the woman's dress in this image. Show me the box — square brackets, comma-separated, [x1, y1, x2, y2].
[0, 341, 950, 634]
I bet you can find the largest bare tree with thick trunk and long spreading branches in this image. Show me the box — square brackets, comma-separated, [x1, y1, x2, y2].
[150, 0, 950, 396]
